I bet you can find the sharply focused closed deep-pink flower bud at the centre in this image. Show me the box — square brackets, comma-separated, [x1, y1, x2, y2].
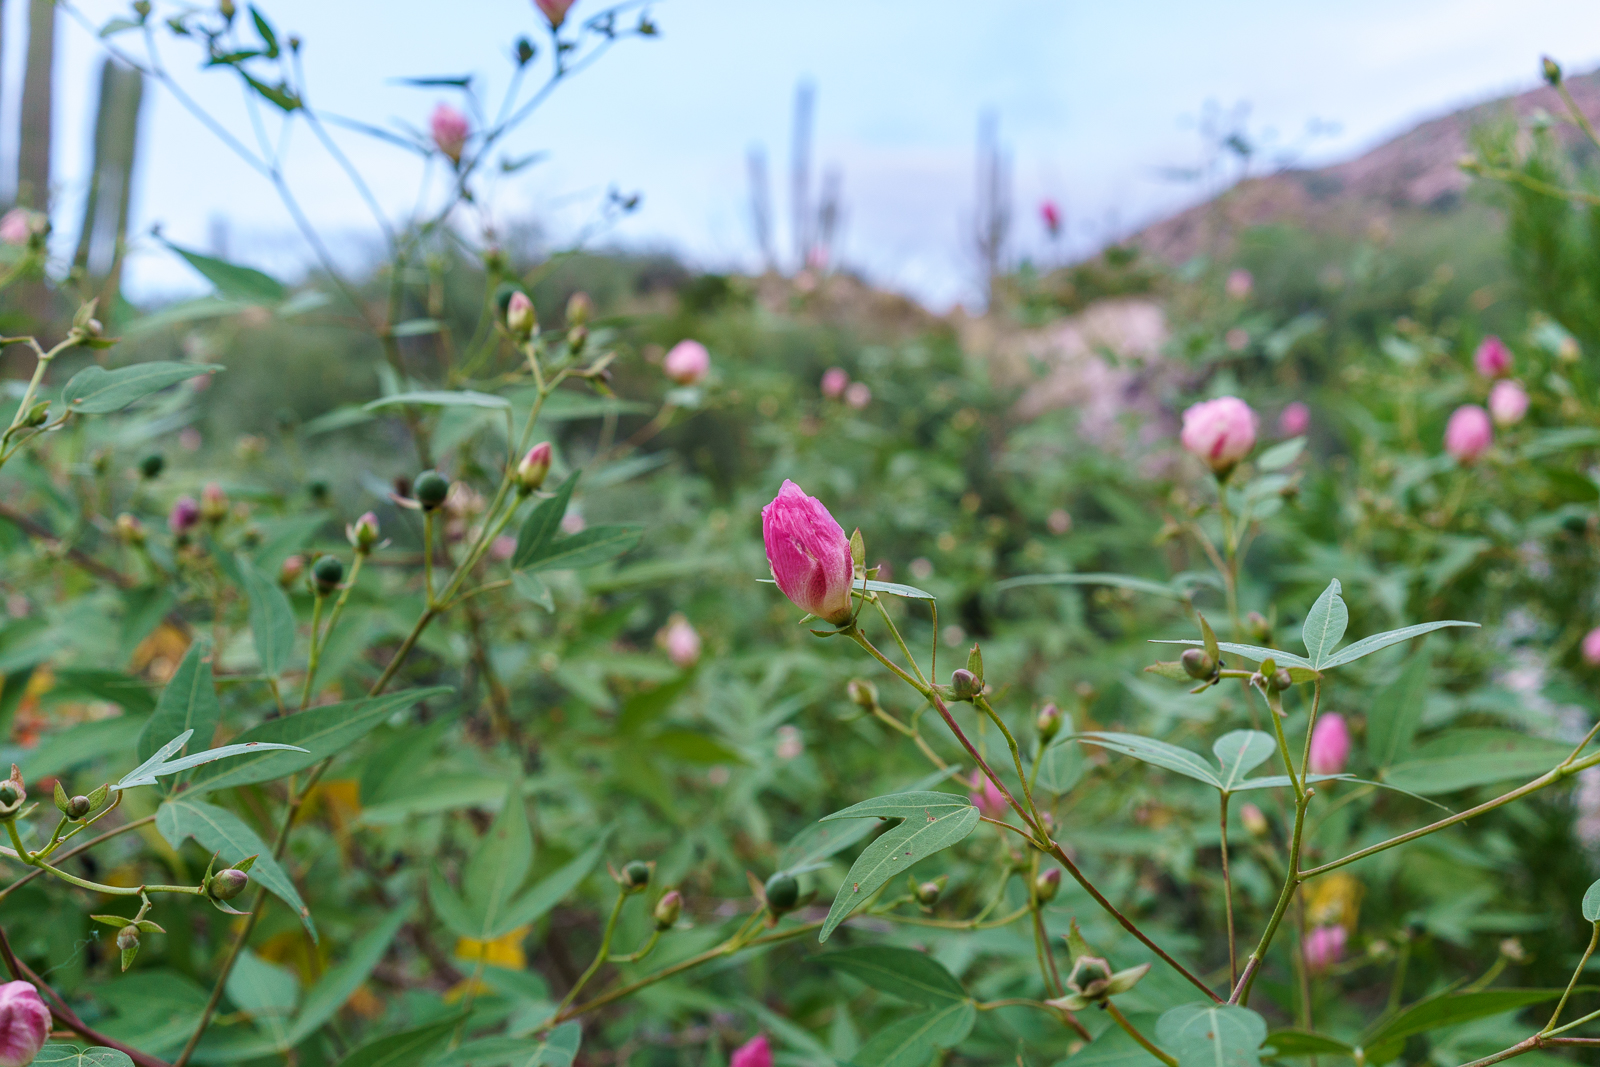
[762, 478, 856, 624]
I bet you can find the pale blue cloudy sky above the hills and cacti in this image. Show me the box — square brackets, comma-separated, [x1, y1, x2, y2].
[25, 0, 1600, 306]
